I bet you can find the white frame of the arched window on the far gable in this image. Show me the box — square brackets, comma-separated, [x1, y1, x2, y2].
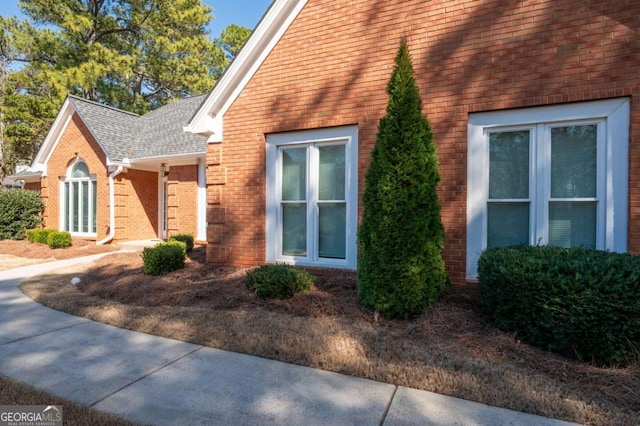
[59, 158, 98, 237]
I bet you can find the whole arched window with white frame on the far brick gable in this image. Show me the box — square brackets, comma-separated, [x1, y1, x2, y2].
[60, 159, 97, 236]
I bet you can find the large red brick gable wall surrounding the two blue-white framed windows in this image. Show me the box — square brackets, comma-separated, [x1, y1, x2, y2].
[207, 0, 640, 282]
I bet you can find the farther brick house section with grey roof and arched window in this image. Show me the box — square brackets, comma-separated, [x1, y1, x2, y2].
[20, 96, 207, 243]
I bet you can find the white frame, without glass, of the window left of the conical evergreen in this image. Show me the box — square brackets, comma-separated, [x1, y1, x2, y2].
[266, 126, 358, 269]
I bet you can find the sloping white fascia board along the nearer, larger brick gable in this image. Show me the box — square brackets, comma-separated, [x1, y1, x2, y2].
[184, 0, 307, 143]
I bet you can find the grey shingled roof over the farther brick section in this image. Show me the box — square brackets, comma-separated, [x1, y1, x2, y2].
[68, 95, 207, 161]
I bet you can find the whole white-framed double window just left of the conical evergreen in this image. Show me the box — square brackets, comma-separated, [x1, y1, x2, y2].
[267, 126, 358, 269]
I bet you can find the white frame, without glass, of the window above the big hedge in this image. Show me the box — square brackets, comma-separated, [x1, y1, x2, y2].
[466, 98, 630, 280]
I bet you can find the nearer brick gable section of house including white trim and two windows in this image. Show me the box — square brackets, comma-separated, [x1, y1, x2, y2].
[184, 0, 640, 283]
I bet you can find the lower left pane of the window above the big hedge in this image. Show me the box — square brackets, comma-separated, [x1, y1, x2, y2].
[487, 203, 529, 248]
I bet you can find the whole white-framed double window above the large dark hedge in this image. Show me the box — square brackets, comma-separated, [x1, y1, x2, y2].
[467, 99, 629, 278]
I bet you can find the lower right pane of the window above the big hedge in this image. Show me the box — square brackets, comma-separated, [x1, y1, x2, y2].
[549, 201, 597, 248]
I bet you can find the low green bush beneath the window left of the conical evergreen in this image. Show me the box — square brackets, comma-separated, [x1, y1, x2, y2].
[244, 265, 315, 299]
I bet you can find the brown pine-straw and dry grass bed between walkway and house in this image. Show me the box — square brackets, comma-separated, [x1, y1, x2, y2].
[22, 248, 640, 425]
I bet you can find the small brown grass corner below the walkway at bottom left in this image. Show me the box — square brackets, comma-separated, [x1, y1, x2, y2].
[0, 376, 135, 426]
